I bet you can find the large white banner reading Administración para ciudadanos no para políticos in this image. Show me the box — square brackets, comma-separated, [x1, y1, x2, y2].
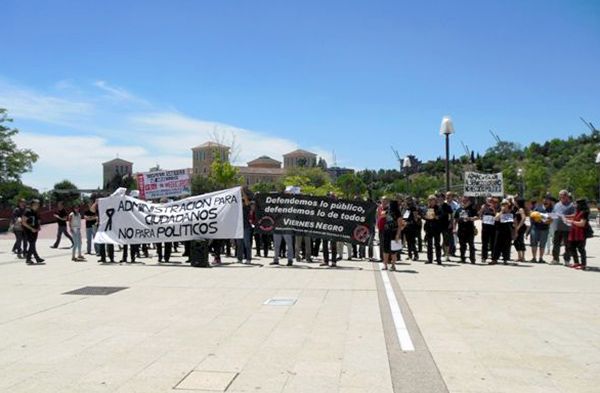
[94, 187, 244, 244]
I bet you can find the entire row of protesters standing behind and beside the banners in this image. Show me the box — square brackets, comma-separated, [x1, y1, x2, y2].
[11, 190, 593, 270]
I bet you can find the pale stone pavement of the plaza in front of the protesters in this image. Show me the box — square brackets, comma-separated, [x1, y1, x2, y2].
[0, 228, 600, 393]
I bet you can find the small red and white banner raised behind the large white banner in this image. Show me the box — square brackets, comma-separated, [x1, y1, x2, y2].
[137, 169, 191, 200]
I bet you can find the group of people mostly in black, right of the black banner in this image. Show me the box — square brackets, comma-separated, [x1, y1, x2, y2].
[377, 190, 593, 270]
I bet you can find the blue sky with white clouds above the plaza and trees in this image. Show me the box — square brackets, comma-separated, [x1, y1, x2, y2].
[0, 0, 600, 190]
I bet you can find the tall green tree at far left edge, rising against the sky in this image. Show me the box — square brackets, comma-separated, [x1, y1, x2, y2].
[0, 108, 38, 183]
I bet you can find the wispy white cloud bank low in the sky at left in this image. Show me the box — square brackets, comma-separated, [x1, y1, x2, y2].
[0, 79, 332, 188]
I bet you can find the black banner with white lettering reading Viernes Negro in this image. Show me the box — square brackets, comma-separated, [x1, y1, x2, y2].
[256, 194, 377, 244]
